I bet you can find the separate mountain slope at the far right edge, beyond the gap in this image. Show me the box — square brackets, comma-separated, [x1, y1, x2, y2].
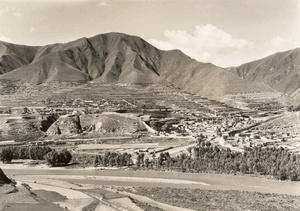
[228, 48, 300, 94]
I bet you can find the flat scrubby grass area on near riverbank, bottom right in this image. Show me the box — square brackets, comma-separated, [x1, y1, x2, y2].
[134, 187, 300, 211]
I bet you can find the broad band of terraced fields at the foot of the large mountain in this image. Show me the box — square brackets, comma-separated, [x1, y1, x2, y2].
[0, 82, 240, 116]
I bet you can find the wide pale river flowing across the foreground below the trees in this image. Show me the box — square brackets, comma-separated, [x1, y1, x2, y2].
[3, 168, 300, 195]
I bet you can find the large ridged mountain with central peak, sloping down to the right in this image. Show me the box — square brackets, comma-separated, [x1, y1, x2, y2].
[0, 33, 273, 97]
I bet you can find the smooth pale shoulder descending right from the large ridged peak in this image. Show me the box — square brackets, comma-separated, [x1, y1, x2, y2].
[159, 50, 274, 98]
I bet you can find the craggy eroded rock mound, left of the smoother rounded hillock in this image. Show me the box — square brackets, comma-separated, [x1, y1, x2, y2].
[46, 115, 82, 136]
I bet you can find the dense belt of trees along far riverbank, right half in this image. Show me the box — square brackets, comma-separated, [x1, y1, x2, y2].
[154, 144, 300, 181]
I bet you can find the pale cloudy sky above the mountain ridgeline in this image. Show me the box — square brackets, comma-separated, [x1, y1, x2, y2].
[0, 0, 300, 67]
